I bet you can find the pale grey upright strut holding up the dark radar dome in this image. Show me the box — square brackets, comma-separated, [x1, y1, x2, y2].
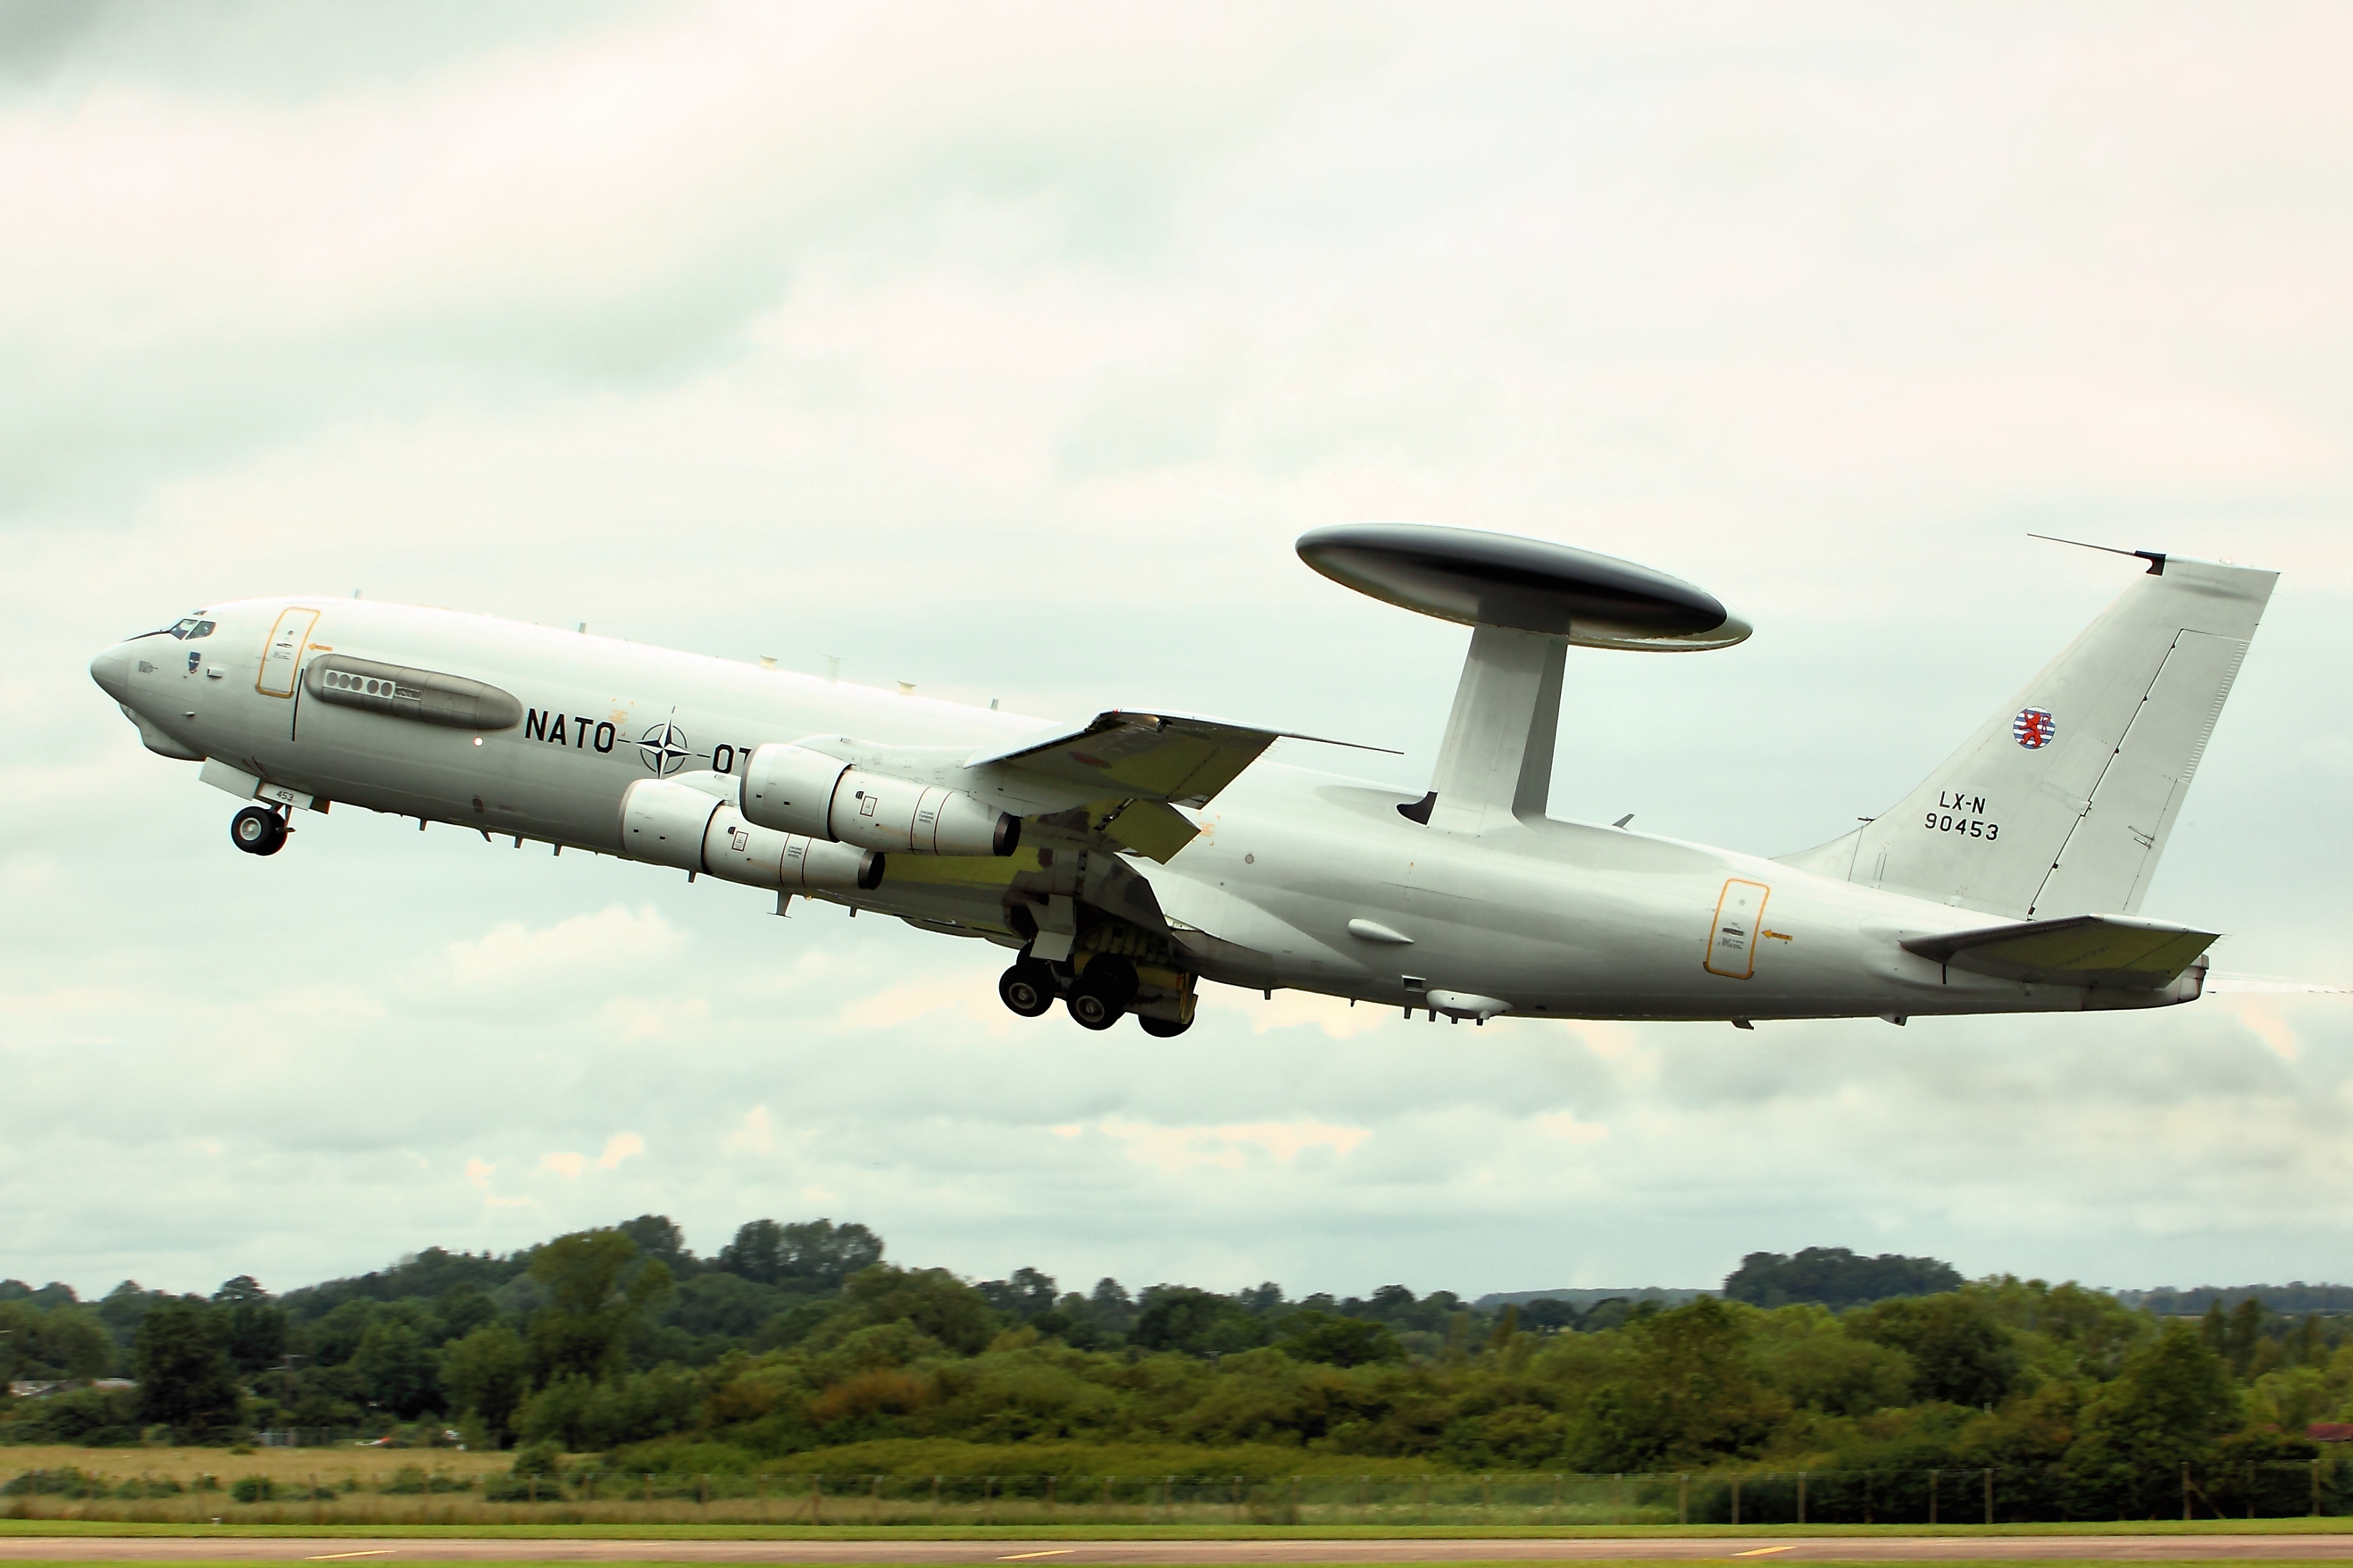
[1429, 625, 1570, 832]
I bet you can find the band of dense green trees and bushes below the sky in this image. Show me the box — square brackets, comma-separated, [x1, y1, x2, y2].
[0, 1215, 2353, 1512]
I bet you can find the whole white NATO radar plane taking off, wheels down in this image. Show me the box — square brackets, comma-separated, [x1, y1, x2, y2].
[89, 524, 2278, 1037]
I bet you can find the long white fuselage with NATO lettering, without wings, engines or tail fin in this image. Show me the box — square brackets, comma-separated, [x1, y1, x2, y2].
[92, 600, 2198, 1020]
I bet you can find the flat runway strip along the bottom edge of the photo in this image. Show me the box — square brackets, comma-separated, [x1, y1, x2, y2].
[0, 1535, 2353, 1568]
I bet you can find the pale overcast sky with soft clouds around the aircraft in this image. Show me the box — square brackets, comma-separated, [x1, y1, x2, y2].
[0, 0, 2353, 1293]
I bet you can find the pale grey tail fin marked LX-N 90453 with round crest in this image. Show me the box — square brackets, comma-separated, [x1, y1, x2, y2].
[1784, 552, 2280, 919]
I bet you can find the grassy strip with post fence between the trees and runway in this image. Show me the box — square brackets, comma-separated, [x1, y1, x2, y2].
[13, 1460, 2353, 1528]
